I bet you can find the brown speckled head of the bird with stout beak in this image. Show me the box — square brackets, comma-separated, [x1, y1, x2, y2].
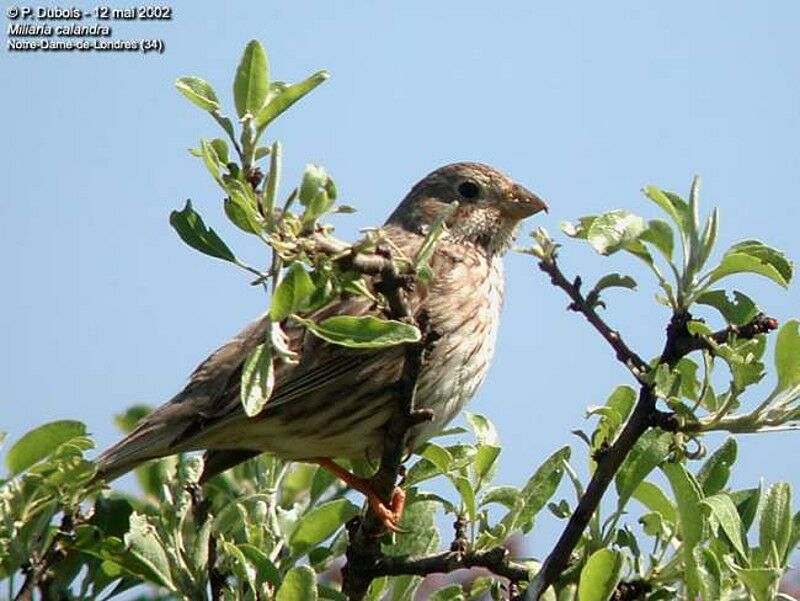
[387, 163, 547, 255]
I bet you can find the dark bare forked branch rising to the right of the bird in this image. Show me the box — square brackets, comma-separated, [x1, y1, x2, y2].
[525, 258, 777, 601]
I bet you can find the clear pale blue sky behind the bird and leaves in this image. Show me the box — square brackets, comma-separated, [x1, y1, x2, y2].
[0, 0, 800, 553]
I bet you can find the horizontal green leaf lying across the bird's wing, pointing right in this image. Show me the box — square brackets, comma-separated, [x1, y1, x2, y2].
[293, 315, 422, 349]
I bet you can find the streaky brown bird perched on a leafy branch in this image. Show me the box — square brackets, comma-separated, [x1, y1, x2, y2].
[96, 162, 548, 530]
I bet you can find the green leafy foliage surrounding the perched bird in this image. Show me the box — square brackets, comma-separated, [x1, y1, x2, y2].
[0, 41, 800, 601]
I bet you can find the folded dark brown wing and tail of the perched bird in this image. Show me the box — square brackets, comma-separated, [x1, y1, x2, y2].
[98, 282, 418, 481]
